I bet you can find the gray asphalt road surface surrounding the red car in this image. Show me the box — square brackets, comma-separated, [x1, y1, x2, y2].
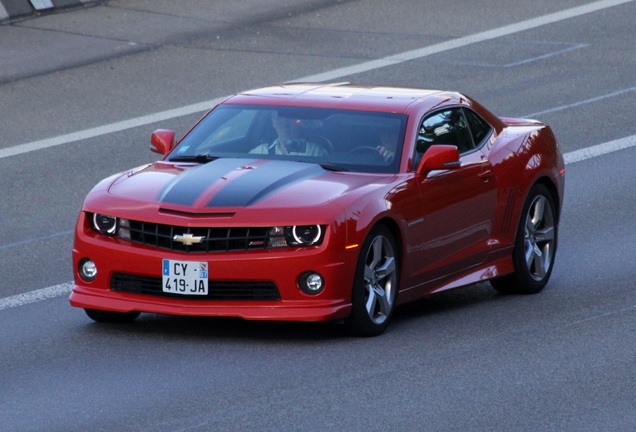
[0, 0, 636, 431]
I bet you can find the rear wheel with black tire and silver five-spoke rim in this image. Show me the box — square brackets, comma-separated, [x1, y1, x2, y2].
[490, 184, 558, 294]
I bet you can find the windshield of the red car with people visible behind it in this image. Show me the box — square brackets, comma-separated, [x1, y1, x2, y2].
[168, 104, 407, 173]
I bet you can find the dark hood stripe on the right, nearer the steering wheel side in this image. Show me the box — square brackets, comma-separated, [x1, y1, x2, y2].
[207, 161, 325, 207]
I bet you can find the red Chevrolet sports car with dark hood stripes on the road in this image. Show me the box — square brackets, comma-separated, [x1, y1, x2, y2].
[70, 83, 565, 335]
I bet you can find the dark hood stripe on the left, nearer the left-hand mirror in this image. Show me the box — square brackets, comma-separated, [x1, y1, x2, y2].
[157, 159, 252, 206]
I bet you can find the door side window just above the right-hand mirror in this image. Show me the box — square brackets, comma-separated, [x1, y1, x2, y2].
[415, 108, 475, 161]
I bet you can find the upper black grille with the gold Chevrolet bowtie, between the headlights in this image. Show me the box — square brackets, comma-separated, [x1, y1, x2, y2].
[129, 220, 271, 253]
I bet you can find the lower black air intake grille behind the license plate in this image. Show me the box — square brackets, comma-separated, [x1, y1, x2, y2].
[110, 273, 280, 300]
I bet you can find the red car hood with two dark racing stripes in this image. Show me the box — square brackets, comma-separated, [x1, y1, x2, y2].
[108, 158, 393, 213]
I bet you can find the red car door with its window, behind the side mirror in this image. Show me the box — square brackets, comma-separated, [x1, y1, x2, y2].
[403, 109, 497, 288]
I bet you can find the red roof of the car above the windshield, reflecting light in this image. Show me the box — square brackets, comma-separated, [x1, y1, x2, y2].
[224, 83, 458, 113]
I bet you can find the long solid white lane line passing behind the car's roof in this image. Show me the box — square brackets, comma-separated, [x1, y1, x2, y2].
[0, 0, 634, 159]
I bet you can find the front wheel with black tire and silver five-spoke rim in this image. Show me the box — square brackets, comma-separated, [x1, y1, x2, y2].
[345, 225, 400, 336]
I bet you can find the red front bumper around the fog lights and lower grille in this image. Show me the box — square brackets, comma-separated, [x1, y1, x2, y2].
[70, 217, 357, 321]
